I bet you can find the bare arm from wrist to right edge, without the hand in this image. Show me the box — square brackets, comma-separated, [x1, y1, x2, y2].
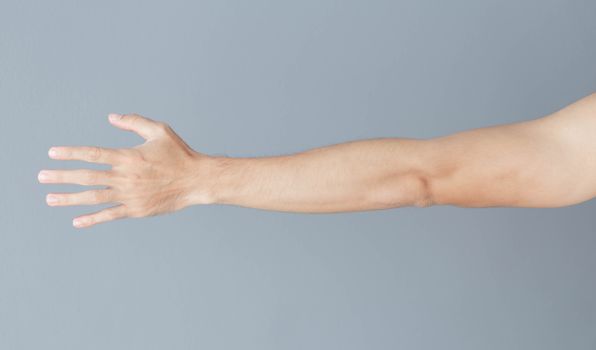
[204, 90, 596, 212]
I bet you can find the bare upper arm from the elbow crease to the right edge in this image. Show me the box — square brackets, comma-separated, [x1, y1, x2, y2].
[430, 94, 596, 207]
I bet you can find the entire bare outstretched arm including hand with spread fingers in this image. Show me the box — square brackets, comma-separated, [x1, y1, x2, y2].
[39, 94, 596, 228]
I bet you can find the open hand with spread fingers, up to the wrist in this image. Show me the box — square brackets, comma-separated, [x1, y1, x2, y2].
[38, 114, 211, 228]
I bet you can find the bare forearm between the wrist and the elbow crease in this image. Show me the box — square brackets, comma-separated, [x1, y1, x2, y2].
[193, 138, 430, 212]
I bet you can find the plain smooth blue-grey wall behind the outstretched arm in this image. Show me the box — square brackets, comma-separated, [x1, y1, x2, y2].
[0, 0, 596, 350]
